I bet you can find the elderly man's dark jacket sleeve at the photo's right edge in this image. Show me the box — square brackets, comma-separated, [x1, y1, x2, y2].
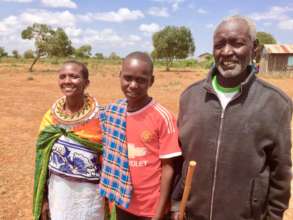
[266, 102, 292, 220]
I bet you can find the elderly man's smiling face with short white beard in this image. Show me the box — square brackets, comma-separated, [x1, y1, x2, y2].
[213, 19, 254, 78]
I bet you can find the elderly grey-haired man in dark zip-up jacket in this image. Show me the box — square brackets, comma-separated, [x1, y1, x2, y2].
[173, 16, 292, 220]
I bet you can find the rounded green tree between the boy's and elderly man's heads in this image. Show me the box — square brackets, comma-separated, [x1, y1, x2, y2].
[152, 26, 195, 71]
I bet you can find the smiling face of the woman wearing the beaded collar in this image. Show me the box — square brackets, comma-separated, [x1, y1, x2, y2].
[58, 63, 89, 98]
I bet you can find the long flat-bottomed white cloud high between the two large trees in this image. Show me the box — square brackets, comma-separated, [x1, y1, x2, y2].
[88, 8, 144, 22]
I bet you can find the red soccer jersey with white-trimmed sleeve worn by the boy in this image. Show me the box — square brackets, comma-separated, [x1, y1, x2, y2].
[120, 100, 182, 217]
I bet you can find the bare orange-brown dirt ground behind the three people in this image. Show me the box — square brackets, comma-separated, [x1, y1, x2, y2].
[0, 64, 293, 220]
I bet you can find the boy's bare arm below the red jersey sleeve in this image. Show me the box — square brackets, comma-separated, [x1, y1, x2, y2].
[152, 158, 174, 220]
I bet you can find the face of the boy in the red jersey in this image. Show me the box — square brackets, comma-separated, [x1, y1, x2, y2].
[120, 57, 154, 105]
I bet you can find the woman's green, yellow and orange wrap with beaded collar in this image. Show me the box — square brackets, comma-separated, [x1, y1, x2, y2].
[33, 95, 105, 220]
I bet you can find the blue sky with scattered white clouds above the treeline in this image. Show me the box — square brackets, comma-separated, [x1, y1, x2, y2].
[0, 0, 293, 56]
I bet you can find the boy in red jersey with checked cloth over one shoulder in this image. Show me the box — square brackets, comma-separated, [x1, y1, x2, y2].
[100, 52, 181, 220]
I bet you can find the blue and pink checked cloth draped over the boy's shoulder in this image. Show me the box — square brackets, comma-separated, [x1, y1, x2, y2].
[99, 99, 132, 208]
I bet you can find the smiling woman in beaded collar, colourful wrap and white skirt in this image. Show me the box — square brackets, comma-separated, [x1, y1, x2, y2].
[33, 61, 104, 220]
